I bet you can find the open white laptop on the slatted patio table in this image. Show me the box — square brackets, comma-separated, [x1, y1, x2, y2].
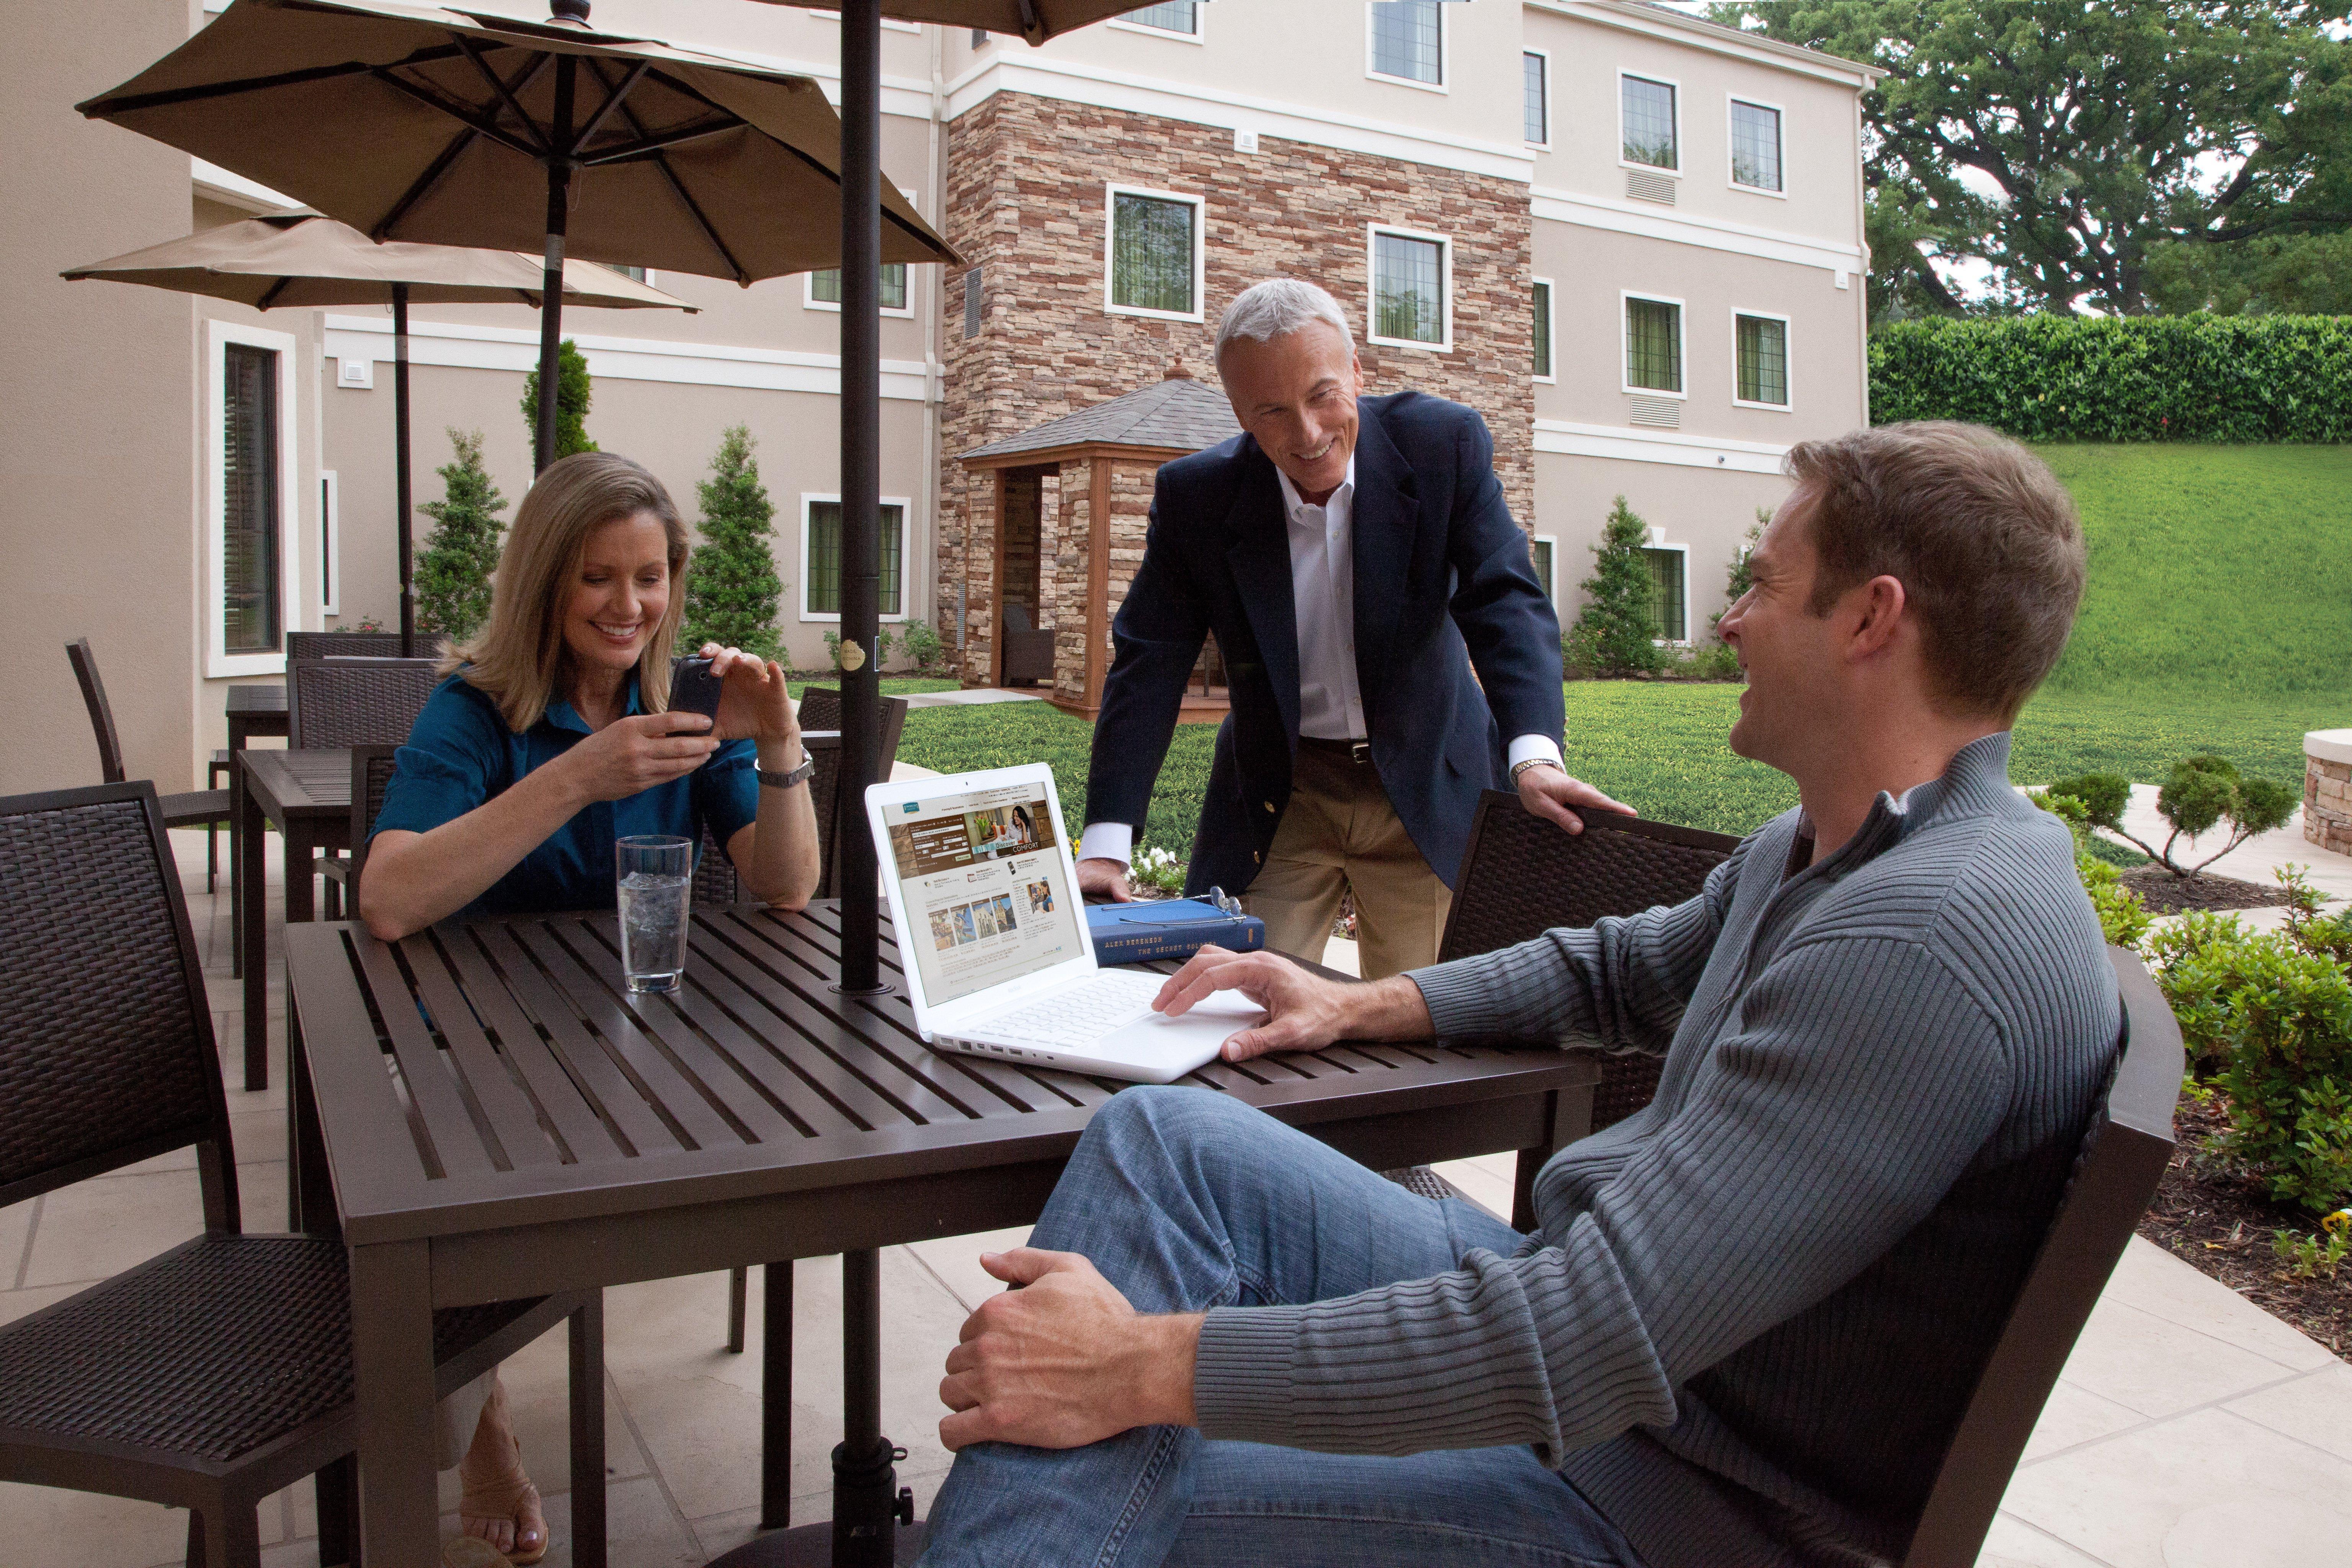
[866, 762, 1265, 1084]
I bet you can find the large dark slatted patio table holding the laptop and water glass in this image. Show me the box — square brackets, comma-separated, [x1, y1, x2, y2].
[287, 900, 1597, 1563]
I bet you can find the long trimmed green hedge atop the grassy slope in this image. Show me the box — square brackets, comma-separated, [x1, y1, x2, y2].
[1870, 315, 2352, 442]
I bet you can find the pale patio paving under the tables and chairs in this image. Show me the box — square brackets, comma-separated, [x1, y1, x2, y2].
[0, 830, 2352, 1568]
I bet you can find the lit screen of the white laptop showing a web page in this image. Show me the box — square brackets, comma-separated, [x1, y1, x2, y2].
[882, 783, 1084, 1006]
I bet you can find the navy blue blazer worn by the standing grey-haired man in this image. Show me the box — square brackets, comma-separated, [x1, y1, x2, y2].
[1087, 393, 1566, 893]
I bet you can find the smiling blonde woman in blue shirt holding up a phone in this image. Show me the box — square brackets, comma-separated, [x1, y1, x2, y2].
[358, 451, 818, 1563]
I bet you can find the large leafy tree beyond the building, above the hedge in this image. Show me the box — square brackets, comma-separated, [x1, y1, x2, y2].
[1710, 0, 2352, 315]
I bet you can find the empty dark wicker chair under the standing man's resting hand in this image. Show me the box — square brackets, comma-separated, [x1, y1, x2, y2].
[1437, 790, 1741, 1131]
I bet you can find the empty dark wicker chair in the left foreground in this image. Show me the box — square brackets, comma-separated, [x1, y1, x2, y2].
[0, 781, 604, 1568]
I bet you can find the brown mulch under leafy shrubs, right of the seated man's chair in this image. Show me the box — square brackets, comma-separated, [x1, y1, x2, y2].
[2140, 1096, 2352, 1361]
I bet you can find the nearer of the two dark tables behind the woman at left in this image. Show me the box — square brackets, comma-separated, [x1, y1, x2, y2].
[230, 745, 350, 1088]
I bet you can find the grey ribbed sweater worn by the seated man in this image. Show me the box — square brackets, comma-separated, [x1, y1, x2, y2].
[1195, 736, 2119, 1568]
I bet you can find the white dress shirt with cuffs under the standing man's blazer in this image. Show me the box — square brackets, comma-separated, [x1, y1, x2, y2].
[1077, 454, 1564, 861]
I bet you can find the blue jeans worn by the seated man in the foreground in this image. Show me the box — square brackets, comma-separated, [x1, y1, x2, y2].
[922, 1088, 1639, 1568]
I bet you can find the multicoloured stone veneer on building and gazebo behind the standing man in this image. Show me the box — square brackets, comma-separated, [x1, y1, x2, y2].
[936, 91, 1536, 682]
